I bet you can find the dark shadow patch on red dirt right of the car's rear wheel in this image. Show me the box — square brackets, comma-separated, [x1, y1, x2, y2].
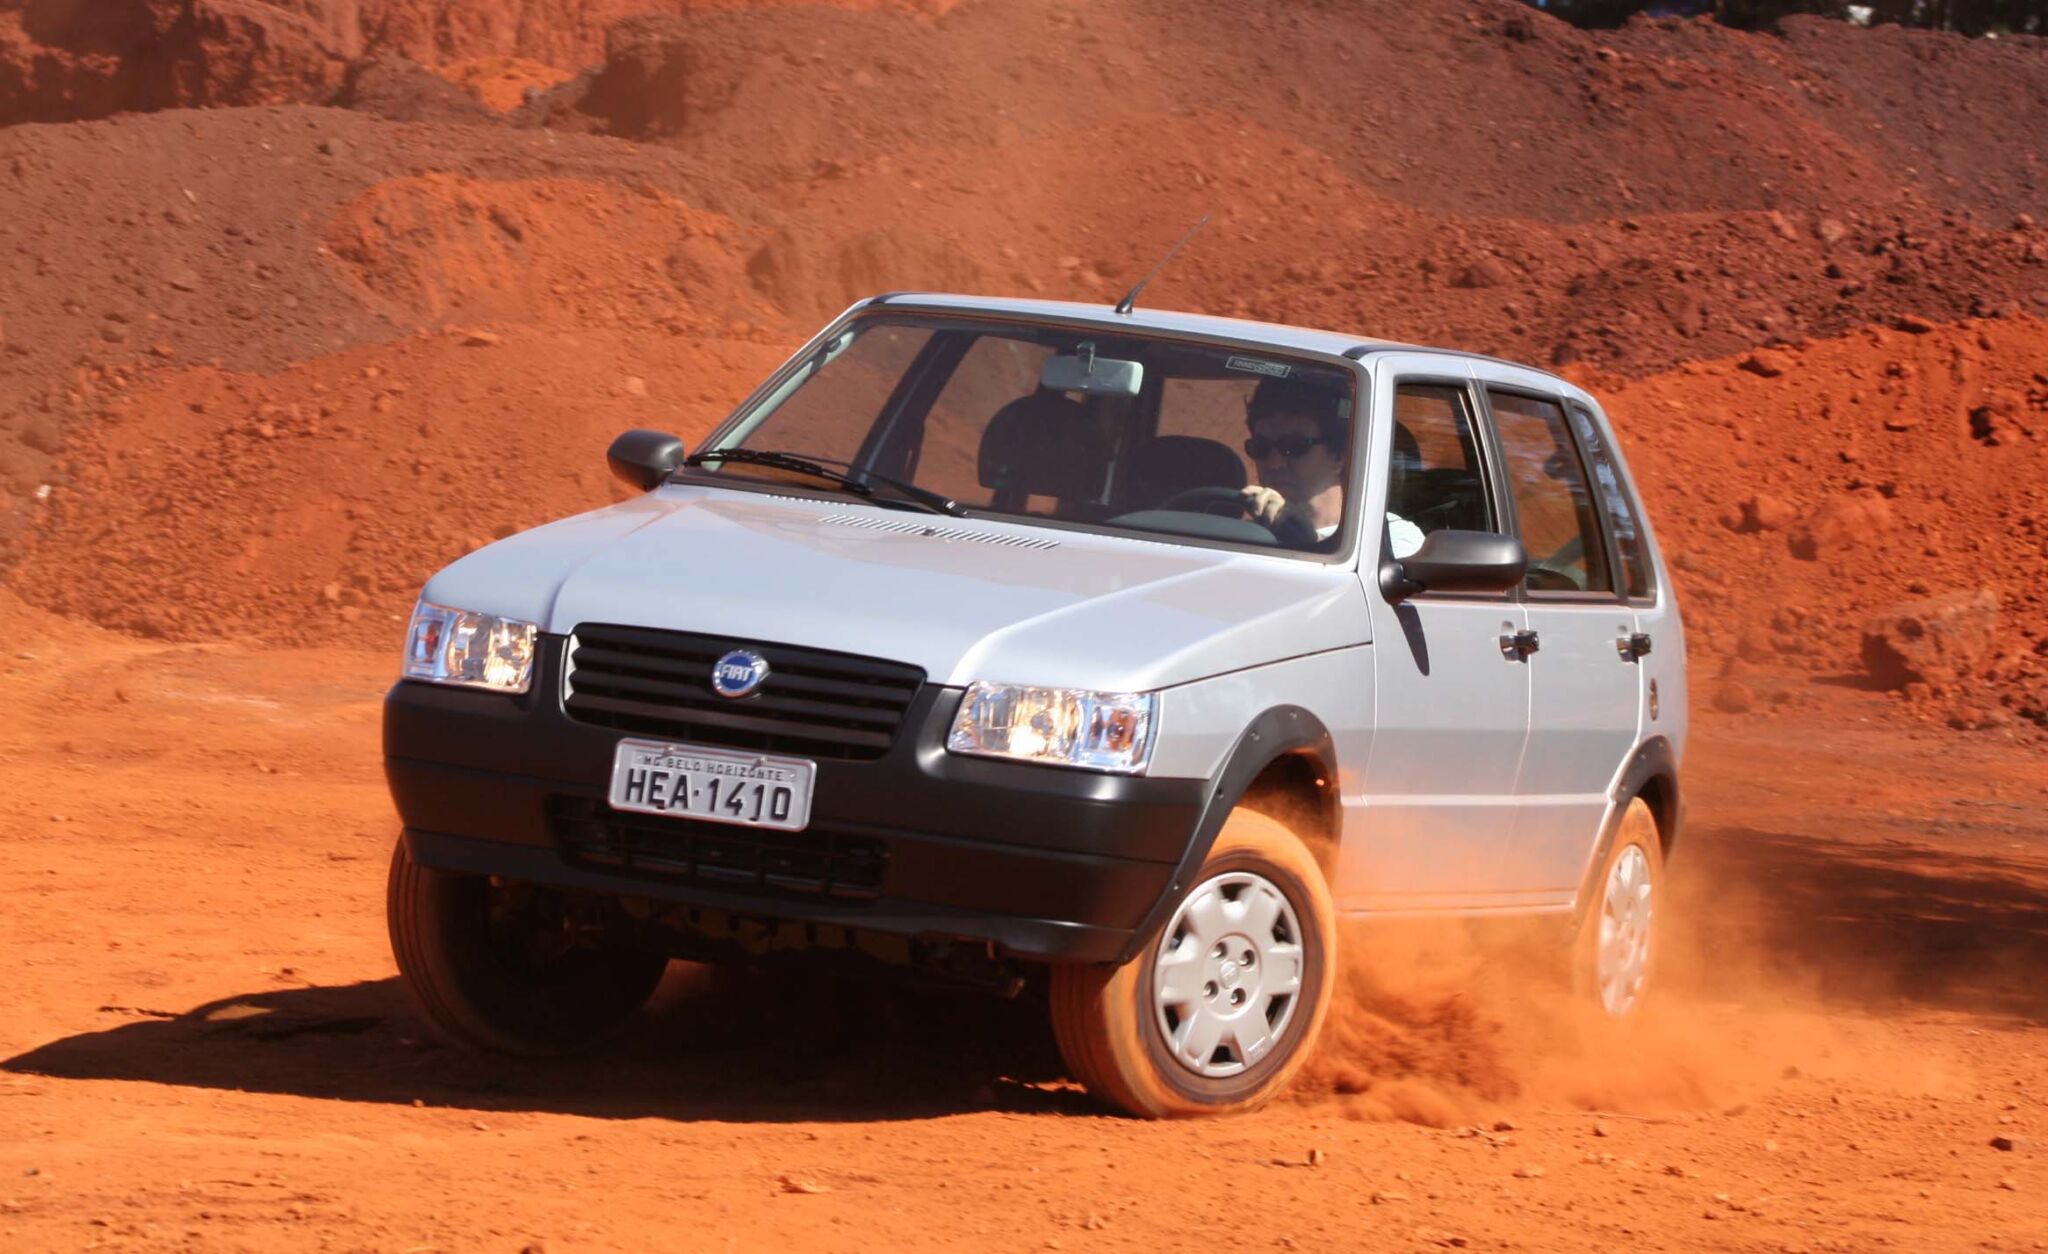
[1671, 824, 2048, 1022]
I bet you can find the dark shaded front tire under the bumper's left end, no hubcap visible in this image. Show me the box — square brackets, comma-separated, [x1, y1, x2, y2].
[385, 836, 668, 1057]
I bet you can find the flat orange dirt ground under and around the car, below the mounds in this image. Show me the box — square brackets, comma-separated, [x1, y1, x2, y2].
[0, 604, 2048, 1252]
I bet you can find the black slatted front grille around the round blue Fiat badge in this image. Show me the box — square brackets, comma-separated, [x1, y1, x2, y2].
[563, 623, 924, 758]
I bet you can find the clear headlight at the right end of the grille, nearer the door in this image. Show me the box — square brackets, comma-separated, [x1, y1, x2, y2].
[946, 682, 1159, 775]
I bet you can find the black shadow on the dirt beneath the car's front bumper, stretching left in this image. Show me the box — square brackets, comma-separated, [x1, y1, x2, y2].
[0, 963, 1100, 1123]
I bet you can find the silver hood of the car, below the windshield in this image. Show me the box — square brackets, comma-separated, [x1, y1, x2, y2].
[424, 486, 1370, 691]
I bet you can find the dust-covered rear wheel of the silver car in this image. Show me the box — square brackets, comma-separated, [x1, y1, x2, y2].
[1571, 797, 1669, 1018]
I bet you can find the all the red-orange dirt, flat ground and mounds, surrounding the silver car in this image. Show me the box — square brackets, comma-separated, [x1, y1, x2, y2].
[0, 0, 2048, 1252]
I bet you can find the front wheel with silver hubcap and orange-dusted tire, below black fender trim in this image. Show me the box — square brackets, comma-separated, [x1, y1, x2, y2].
[1051, 809, 1337, 1119]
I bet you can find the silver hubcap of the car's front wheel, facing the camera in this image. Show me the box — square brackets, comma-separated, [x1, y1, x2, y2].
[1153, 871, 1303, 1078]
